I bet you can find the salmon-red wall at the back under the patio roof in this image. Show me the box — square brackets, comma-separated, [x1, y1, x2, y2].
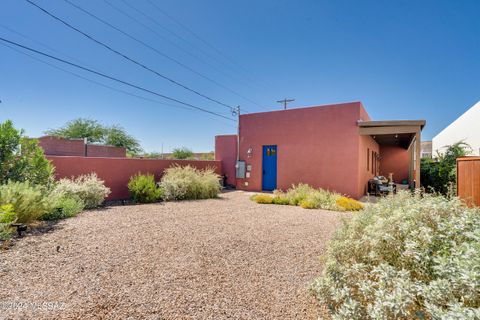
[380, 146, 410, 183]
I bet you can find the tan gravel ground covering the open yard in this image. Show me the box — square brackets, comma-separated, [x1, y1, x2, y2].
[0, 191, 346, 320]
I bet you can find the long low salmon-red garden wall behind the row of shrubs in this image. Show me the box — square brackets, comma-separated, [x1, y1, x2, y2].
[47, 156, 221, 200]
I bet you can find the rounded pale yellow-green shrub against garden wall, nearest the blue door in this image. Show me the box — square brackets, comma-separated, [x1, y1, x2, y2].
[160, 165, 221, 200]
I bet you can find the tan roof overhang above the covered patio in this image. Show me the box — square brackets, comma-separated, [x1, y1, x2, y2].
[358, 120, 426, 149]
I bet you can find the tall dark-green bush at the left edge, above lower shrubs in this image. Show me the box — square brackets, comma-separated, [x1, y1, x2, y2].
[0, 120, 53, 186]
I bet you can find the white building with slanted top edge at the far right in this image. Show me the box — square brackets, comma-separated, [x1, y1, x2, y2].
[432, 101, 480, 156]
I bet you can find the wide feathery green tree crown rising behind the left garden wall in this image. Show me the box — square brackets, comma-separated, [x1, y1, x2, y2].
[45, 118, 142, 154]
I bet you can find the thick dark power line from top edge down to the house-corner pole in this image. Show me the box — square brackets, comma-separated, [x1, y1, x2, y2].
[25, 0, 233, 110]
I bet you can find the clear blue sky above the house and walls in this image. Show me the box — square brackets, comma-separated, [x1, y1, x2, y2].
[0, 0, 480, 152]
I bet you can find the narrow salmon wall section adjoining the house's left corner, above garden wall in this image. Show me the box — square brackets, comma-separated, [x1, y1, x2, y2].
[215, 134, 237, 186]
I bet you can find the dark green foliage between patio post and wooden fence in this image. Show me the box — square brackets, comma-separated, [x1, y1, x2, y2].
[420, 141, 471, 195]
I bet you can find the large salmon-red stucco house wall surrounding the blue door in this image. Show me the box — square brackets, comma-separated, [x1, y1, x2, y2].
[237, 102, 368, 198]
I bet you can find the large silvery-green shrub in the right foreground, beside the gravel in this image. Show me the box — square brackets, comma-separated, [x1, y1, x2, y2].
[311, 192, 480, 319]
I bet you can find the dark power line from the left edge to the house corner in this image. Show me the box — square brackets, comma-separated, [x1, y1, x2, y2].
[0, 37, 235, 121]
